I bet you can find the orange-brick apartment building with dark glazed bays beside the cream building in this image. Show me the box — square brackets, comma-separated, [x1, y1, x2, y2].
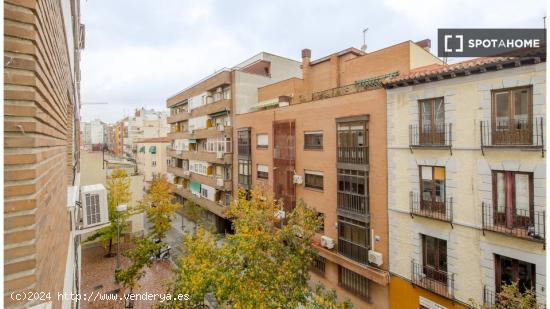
[233, 41, 441, 308]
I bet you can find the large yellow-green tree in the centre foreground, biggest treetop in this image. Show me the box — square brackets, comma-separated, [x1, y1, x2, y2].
[166, 188, 354, 308]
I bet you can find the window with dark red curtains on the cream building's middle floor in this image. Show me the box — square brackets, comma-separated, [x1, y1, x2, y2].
[493, 171, 534, 228]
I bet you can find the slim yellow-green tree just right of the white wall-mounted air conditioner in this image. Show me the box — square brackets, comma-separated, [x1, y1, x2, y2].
[86, 168, 131, 257]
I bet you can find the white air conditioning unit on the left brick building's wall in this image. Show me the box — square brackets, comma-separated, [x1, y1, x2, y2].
[80, 184, 109, 228]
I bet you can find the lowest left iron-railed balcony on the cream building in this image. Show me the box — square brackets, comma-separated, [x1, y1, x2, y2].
[411, 260, 454, 299]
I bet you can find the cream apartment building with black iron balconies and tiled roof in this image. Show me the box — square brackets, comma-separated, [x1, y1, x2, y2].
[385, 54, 546, 308]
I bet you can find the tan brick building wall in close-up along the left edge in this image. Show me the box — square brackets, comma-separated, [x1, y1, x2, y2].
[4, 0, 84, 308]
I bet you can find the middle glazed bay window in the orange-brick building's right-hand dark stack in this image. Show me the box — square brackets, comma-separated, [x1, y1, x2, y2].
[337, 169, 368, 214]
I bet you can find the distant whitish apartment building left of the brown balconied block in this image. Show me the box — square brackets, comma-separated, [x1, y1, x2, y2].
[123, 107, 169, 162]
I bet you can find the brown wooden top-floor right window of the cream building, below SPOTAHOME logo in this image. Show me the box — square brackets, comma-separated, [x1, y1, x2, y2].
[491, 87, 533, 145]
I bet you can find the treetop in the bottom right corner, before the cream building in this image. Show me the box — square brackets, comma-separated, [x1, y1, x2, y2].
[470, 282, 544, 309]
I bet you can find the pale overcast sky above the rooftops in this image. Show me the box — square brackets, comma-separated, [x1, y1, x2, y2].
[81, 0, 546, 122]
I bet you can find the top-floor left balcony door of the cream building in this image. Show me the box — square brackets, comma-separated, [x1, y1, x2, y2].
[418, 98, 445, 145]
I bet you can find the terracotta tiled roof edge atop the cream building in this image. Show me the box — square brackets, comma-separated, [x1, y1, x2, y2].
[383, 51, 546, 88]
